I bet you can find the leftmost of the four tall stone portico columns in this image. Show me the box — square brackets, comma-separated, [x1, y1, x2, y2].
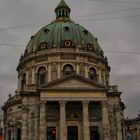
[39, 101, 46, 140]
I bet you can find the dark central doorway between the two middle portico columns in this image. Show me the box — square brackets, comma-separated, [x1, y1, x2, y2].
[68, 126, 78, 140]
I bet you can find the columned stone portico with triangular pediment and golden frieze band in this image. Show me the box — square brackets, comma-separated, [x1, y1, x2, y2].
[40, 76, 109, 140]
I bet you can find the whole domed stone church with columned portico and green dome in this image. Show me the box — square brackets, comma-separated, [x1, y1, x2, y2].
[2, 0, 125, 140]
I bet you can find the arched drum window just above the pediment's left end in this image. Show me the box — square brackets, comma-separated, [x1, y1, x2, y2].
[37, 67, 46, 86]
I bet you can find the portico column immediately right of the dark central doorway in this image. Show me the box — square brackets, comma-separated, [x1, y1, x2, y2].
[82, 101, 90, 140]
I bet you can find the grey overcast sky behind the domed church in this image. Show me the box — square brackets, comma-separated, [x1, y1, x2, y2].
[0, 0, 140, 118]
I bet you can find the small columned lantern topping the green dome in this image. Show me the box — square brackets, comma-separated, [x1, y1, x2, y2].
[55, 0, 71, 19]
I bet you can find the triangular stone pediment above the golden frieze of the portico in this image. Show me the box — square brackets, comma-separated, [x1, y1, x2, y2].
[43, 75, 105, 89]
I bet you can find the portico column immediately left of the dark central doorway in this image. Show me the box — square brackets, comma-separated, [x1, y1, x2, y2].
[59, 101, 67, 140]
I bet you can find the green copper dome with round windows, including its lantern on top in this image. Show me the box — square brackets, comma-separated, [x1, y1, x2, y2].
[25, 0, 103, 55]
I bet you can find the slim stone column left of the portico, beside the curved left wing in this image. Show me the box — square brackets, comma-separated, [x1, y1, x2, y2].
[21, 97, 28, 140]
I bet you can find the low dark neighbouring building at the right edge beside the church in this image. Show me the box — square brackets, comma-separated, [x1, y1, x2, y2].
[125, 114, 140, 140]
